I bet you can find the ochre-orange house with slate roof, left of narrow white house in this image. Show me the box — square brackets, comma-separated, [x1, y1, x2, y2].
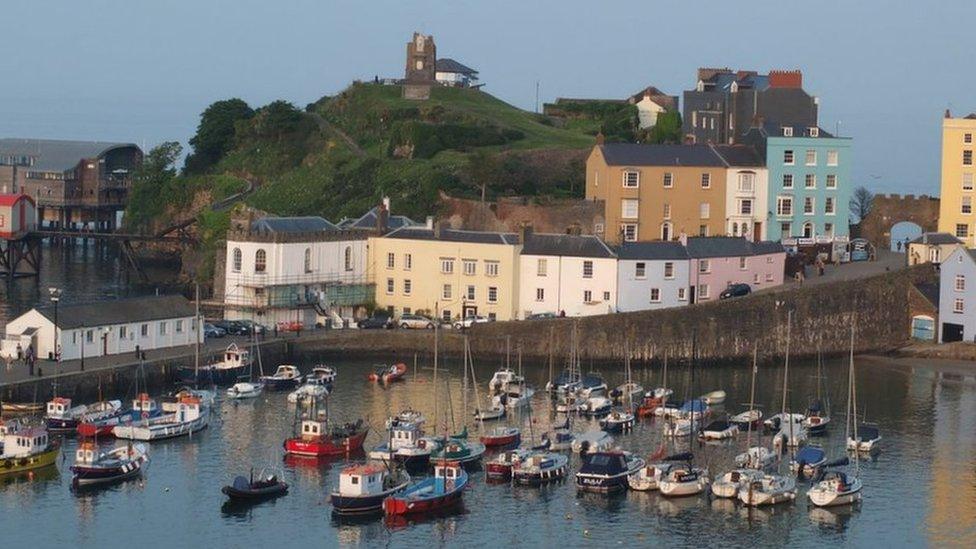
[586, 143, 727, 244]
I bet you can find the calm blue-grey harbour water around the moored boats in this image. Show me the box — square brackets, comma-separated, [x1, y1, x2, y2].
[0, 357, 976, 547]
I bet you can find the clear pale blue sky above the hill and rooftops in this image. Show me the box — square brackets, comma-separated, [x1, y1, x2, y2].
[0, 0, 976, 193]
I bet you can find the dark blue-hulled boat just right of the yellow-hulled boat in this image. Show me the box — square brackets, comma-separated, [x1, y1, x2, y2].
[71, 440, 149, 488]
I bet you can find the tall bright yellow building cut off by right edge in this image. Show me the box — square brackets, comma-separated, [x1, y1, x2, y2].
[939, 111, 976, 244]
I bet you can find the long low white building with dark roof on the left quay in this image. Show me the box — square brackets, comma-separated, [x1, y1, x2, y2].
[0, 295, 200, 360]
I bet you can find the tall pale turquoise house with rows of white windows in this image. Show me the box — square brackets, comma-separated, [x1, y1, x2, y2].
[743, 123, 854, 240]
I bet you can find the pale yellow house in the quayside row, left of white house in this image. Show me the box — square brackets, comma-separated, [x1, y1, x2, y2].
[368, 226, 521, 321]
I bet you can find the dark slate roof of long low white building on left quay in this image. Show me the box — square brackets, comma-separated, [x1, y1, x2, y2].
[36, 295, 196, 330]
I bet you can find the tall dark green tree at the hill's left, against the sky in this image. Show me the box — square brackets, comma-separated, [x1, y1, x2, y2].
[183, 98, 254, 174]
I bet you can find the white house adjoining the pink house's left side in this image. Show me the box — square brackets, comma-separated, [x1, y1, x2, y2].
[617, 241, 690, 312]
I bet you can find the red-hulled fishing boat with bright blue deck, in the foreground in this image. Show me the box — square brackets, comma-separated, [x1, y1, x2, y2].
[383, 460, 468, 516]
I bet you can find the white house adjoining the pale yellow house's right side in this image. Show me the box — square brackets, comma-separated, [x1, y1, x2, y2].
[519, 228, 617, 318]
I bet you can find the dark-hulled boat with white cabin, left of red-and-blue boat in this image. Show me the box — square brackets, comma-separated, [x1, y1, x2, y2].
[330, 464, 410, 516]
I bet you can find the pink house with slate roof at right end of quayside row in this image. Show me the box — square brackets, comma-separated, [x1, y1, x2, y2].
[682, 236, 786, 303]
